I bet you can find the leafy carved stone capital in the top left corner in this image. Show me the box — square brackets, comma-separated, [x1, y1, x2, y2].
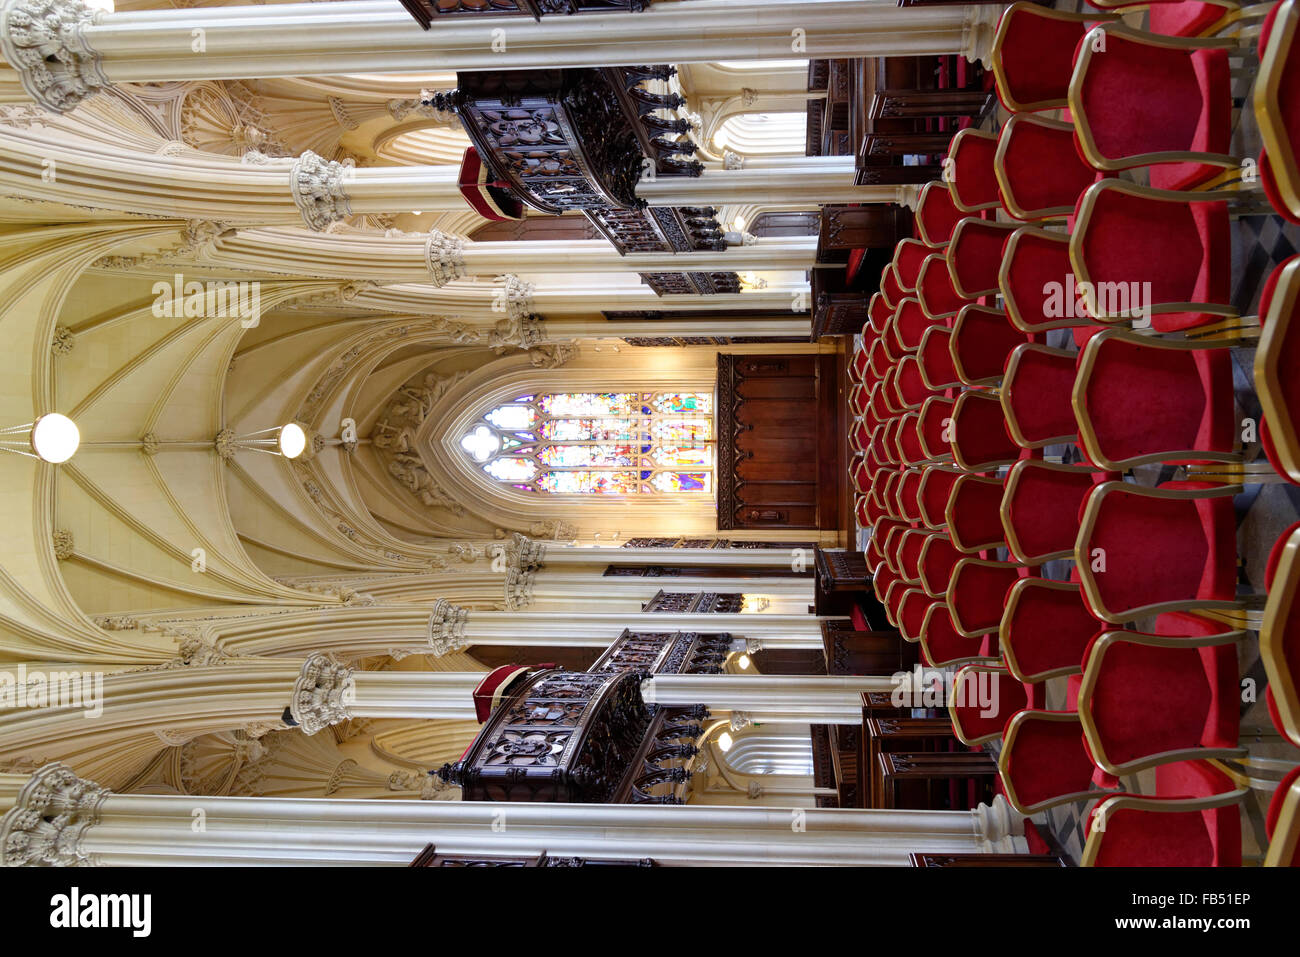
[0, 0, 109, 113]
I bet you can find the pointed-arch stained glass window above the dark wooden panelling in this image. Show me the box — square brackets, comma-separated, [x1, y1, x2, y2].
[460, 391, 715, 495]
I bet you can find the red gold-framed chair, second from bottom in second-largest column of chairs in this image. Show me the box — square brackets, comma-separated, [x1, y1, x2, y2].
[998, 579, 1102, 683]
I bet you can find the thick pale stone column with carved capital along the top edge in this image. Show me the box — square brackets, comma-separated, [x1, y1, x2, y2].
[0, 0, 998, 111]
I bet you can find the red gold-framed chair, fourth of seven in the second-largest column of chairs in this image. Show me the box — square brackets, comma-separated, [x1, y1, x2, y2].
[998, 342, 1079, 449]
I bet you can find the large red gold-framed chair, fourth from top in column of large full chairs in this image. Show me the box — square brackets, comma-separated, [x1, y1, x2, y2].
[1074, 482, 1240, 624]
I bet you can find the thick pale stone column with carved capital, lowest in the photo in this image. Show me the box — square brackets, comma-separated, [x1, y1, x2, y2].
[0, 765, 1024, 867]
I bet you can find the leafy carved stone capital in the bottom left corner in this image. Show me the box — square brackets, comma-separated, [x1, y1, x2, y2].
[0, 763, 109, 867]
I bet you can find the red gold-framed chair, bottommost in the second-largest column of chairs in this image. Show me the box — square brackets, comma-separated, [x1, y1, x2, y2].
[997, 709, 1114, 814]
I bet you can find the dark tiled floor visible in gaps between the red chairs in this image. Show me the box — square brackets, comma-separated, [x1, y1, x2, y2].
[852, 0, 1300, 862]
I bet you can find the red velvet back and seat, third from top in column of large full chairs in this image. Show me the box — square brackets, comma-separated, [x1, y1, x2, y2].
[1084, 339, 1236, 460]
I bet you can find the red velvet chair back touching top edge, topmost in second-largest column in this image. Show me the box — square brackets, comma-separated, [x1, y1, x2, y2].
[997, 8, 1087, 109]
